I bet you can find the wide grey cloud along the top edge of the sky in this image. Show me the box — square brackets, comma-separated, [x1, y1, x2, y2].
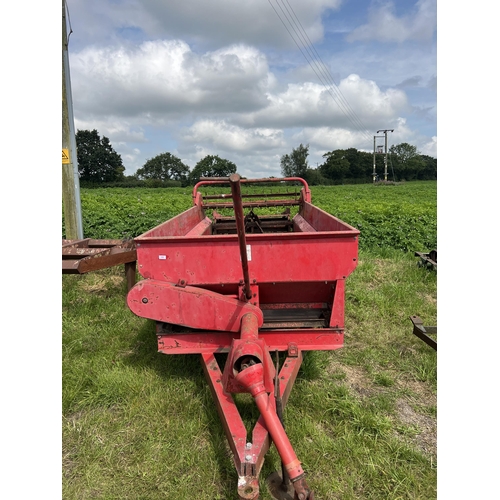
[69, 0, 342, 49]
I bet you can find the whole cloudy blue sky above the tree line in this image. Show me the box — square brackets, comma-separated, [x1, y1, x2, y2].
[67, 0, 437, 178]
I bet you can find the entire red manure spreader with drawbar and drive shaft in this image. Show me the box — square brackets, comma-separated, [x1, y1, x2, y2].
[127, 174, 359, 500]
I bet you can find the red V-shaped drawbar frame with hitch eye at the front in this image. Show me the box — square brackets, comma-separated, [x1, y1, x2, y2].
[201, 350, 302, 500]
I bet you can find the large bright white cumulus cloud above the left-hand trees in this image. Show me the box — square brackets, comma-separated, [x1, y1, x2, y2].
[72, 40, 274, 122]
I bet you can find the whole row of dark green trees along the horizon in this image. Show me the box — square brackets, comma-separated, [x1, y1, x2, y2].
[76, 129, 437, 187]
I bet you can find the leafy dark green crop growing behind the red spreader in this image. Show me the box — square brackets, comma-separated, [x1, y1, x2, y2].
[62, 181, 437, 252]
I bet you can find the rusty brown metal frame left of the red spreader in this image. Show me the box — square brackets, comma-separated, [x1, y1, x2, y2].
[62, 238, 137, 290]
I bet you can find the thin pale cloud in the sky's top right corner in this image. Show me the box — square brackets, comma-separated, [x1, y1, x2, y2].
[346, 0, 437, 43]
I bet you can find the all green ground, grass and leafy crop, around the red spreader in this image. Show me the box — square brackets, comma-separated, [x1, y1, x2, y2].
[62, 181, 437, 500]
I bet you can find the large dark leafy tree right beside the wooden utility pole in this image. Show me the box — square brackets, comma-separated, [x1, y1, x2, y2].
[76, 129, 125, 183]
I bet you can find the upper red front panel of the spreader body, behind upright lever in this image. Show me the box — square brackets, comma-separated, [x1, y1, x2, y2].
[136, 232, 358, 286]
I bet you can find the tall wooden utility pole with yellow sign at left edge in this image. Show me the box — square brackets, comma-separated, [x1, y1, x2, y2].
[62, 0, 83, 240]
